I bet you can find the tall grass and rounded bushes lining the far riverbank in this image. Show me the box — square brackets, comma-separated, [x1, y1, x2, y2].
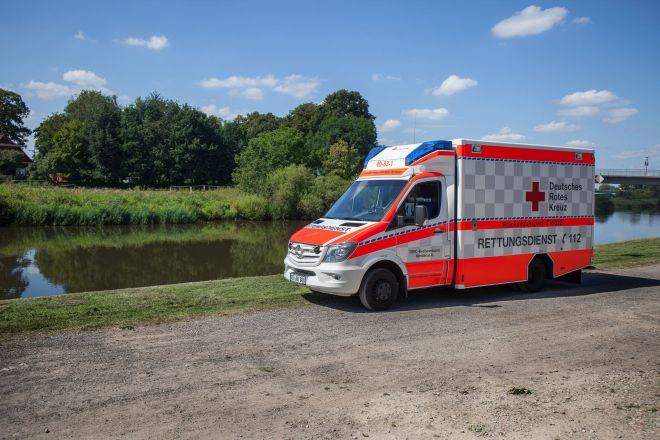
[0, 165, 350, 226]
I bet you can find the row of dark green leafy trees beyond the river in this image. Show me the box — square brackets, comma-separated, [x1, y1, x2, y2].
[0, 90, 376, 190]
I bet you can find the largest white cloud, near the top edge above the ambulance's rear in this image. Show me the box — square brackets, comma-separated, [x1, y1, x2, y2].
[491, 5, 568, 38]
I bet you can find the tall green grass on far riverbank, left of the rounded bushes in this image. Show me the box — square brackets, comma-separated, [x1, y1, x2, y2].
[0, 184, 270, 226]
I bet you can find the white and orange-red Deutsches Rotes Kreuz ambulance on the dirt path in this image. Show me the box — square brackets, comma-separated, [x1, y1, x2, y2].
[284, 139, 595, 310]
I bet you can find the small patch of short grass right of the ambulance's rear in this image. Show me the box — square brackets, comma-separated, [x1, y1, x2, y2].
[592, 237, 660, 269]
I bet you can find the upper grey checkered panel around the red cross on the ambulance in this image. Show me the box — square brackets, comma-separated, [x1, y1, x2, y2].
[458, 157, 594, 220]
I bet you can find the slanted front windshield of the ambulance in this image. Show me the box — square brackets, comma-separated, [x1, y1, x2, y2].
[324, 180, 407, 222]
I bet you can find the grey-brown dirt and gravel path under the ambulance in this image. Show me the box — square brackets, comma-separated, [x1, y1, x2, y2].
[0, 265, 660, 439]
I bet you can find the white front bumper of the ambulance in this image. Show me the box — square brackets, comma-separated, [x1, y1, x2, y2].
[284, 256, 364, 296]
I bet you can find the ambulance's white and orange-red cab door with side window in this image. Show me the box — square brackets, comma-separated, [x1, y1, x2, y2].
[391, 177, 451, 289]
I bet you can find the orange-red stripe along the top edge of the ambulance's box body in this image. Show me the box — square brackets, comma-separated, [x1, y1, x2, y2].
[456, 144, 595, 165]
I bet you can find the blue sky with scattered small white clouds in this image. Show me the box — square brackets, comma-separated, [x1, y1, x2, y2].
[0, 0, 660, 169]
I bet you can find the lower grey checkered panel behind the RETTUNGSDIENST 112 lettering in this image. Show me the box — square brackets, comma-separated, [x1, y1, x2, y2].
[459, 226, 593, 258]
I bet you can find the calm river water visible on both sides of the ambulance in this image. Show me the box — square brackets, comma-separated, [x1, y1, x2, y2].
[0, 212, 660, 299]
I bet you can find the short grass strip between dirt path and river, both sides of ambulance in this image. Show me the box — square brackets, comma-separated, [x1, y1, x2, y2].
[0, 237, 660, 336]
